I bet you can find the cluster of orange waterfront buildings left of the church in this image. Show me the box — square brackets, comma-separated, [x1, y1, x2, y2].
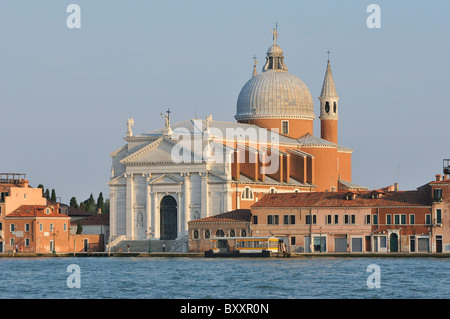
[0, 173, 104, 253]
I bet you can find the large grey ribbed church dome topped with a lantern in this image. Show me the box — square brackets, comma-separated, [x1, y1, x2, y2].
[235, 34, 315, 121]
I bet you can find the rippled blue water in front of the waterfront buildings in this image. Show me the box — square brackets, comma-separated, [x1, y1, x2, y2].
[0, 257, 450, 299]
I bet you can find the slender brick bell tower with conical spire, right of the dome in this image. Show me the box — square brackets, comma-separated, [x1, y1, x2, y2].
[319, 58, 339, 144]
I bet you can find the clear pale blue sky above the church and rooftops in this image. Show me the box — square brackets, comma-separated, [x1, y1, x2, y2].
[0, 0, 450, 203]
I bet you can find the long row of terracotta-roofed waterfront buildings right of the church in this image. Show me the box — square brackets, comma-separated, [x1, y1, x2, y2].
[251, 179, 450, 253]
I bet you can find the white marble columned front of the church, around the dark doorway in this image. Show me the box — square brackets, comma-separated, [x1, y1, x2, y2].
[108, 119, 232, 240]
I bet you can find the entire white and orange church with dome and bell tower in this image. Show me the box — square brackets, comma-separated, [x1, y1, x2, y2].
[108, 30, 360, 244]
